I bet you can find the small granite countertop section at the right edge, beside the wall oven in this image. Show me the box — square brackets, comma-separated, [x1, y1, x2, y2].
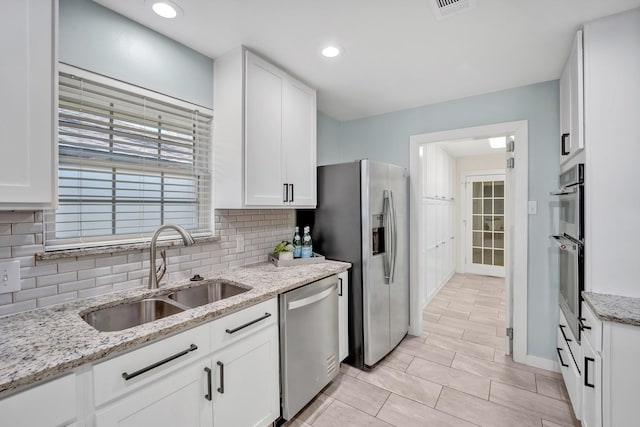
[582, 292, 640, 326]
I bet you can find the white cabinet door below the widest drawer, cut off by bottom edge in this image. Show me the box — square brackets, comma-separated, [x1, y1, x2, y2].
[96, 359, 211, 427]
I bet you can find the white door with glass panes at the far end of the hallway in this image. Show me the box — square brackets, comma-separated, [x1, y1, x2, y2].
[465, 174, 505, 277]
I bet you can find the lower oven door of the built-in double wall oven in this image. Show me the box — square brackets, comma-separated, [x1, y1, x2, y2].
[552, 236, 584, 341]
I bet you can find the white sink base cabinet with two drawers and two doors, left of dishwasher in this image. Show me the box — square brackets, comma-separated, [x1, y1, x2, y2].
[93, 298, 280, 427]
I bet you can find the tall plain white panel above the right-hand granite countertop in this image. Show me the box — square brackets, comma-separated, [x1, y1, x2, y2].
[584, 8, 640, 298]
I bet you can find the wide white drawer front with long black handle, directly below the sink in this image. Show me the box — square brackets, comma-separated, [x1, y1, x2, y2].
[93, 324, 211, 406]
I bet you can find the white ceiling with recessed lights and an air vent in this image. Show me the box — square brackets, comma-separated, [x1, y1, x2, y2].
[95, 0, 640, 120]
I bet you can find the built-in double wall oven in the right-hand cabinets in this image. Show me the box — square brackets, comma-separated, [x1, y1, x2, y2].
[551, 163, 585, 341]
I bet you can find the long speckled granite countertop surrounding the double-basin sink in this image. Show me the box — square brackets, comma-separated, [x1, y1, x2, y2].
[0, 261, 351, 398]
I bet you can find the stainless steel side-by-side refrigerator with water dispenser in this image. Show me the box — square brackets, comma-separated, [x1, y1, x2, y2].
[312, 160, 409, 369]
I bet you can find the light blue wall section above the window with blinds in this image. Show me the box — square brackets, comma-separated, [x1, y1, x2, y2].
[59, 0, 213, 108]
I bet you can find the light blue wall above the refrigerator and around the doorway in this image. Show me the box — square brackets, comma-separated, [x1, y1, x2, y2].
[318, 80, 560, 360]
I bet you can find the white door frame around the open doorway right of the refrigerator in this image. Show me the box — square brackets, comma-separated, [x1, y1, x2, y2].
[409, 121, 528, 363]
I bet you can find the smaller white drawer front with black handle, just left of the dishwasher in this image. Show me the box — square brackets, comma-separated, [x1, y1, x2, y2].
[211, 298, 278, 351]
